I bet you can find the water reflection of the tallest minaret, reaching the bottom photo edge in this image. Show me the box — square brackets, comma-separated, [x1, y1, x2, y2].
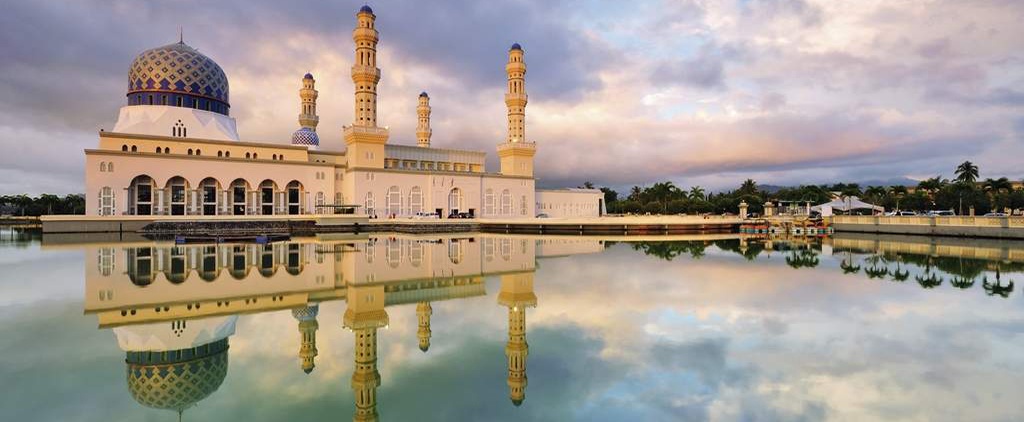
[344, 285, 388, 421]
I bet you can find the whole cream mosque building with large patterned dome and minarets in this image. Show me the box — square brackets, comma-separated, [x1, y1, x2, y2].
[85, 6, 604, 218]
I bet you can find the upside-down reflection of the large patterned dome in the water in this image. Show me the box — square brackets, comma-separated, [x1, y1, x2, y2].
[125, 338, 227, 412]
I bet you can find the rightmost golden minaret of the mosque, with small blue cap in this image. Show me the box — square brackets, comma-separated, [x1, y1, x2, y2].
[498, 43, 537, 177]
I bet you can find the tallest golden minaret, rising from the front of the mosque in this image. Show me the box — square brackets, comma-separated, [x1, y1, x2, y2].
[343, 6, 388, 168]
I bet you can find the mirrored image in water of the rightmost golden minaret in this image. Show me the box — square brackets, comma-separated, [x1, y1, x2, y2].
[498, 272, 537, 406]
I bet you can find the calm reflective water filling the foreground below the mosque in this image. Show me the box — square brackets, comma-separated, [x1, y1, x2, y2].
[0, 229, 1024, 421]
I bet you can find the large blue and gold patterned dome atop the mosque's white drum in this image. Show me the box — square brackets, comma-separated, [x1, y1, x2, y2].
[128, 41, 230, 116]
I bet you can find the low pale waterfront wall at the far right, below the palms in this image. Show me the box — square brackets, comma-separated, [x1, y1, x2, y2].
[833, 215, 1024, 239]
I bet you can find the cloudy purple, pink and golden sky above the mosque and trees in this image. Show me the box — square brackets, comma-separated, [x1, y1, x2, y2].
[0, 0, 1024, 195]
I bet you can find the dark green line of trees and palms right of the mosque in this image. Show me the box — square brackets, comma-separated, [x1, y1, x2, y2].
[582, 161, 1024, 215]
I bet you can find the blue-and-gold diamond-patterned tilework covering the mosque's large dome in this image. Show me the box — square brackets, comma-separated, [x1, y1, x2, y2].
[128, 42, 229, 110]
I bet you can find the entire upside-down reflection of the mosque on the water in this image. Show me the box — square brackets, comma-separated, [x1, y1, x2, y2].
[85, 235, 604, 421]
